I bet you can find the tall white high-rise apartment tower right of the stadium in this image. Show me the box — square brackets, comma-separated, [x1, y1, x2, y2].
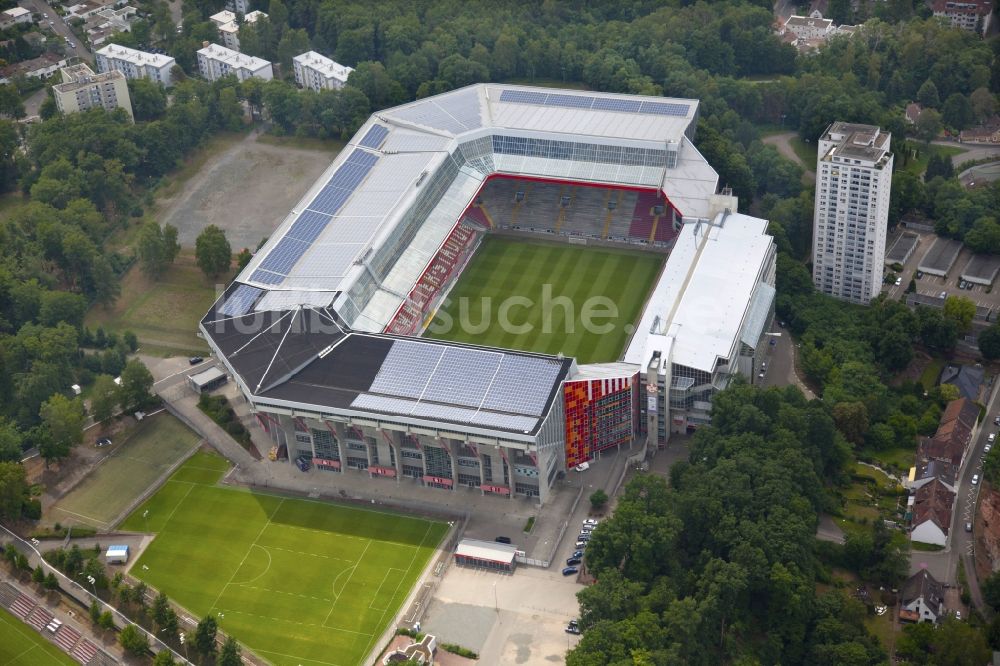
[813, 122, 893, 304]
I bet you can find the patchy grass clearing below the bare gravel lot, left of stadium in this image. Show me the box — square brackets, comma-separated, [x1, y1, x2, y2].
[84, 251, 229, 356]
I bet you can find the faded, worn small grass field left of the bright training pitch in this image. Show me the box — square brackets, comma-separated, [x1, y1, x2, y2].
[50, 413, 198, 529]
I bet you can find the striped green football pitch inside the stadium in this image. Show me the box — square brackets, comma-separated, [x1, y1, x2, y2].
[425, 236, 664, 363]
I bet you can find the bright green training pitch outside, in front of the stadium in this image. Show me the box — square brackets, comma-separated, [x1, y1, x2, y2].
[122, 452, 448, 666]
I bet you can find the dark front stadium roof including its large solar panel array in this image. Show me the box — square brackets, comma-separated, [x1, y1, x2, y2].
[202, 285, 573, 435]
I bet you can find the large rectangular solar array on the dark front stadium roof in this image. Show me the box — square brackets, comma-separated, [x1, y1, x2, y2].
[368, 340, 562, 416]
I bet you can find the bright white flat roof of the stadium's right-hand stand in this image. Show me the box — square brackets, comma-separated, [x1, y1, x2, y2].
[625, 213, 774, 372]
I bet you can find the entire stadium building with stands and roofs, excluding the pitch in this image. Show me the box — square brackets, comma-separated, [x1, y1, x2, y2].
[200, 84, 775, 502]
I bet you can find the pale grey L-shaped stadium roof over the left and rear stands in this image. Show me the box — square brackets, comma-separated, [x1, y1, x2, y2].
[237, 84, 718, 331]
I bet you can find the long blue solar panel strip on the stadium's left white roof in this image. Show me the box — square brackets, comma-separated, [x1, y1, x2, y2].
[250, 149, 378, 284]
